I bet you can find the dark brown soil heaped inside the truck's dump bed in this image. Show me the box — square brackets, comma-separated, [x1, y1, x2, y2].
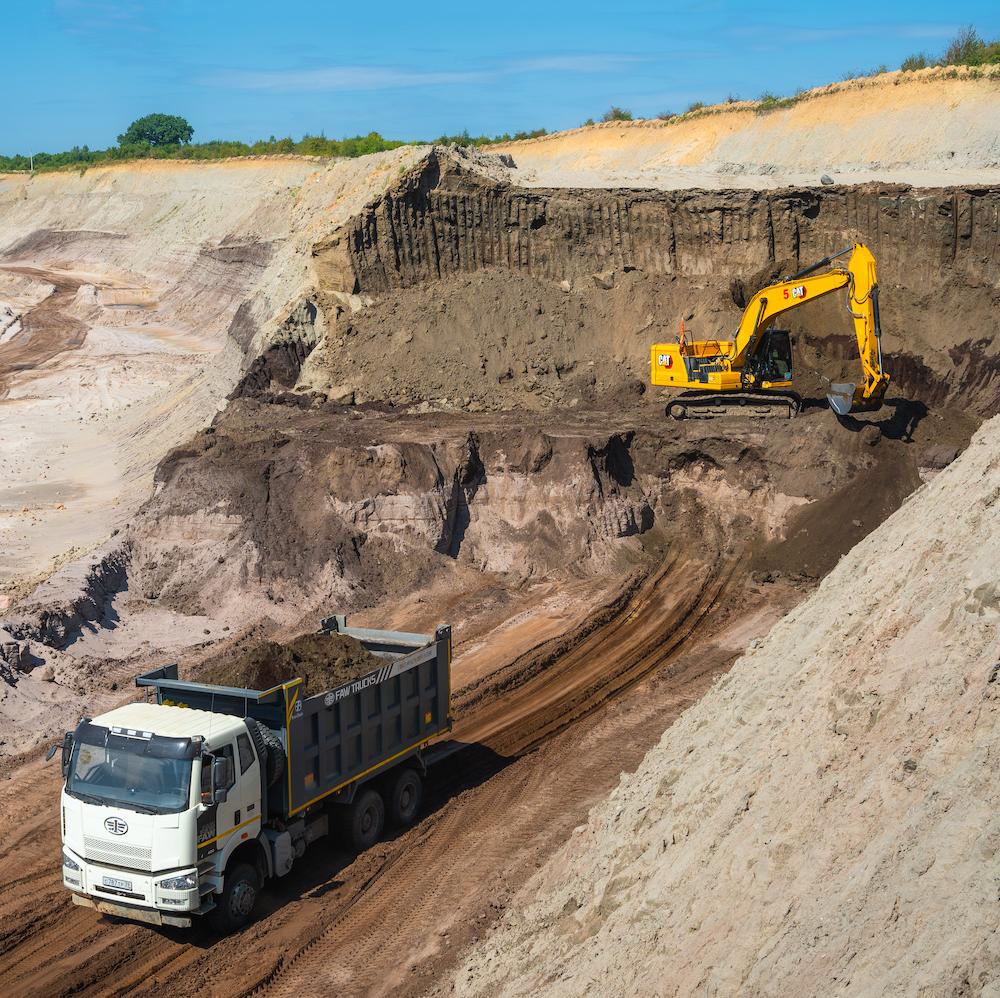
[197, 634, 385, 693]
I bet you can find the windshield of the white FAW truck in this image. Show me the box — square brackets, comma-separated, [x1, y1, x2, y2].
[66, 725, 193, 814]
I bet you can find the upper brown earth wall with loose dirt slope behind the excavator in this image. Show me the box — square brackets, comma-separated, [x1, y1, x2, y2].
[301, 153, 1000, 415]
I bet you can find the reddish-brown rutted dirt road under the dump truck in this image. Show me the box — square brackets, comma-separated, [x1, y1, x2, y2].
[0, 562, 796, 995]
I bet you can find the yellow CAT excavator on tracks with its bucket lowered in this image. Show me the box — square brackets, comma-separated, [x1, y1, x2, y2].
[649, 243, 889, 419]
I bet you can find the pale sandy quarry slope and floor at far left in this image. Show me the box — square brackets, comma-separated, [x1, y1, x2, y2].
[0, 148, 426, 600]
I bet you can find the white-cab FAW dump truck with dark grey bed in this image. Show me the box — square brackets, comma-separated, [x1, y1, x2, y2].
[49, 616, 451, 932]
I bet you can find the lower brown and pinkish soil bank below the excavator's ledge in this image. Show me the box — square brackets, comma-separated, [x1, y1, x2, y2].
[119, 399, 966, 626]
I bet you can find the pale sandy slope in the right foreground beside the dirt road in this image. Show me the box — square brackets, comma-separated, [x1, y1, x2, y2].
[455, 418, 1000, 995]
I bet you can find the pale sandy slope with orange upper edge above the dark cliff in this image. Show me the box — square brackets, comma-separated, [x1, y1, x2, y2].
[495, 70, 1000, 189]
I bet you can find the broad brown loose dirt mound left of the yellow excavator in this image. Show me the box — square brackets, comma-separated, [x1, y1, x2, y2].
[299, 270, 680, 411]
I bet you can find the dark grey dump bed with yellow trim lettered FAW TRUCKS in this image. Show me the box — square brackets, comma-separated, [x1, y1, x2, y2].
[136, 616, 451, 816]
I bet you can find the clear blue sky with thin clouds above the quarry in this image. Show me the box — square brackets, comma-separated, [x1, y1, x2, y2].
[0, 0, 1000, 153]
